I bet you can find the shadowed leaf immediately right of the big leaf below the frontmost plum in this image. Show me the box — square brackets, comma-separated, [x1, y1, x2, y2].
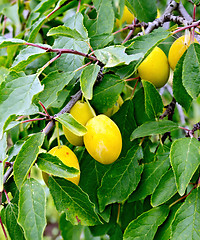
[129, 155, 170, 202]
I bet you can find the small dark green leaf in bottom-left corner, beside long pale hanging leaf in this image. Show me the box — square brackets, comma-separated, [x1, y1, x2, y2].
[1, 203, 25, 240]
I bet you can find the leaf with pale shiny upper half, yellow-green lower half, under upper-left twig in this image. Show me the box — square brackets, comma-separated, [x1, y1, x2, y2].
[11, 47, 46, 72]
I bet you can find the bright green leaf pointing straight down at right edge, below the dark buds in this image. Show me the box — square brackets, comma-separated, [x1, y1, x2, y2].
[170, 138, 200, 196]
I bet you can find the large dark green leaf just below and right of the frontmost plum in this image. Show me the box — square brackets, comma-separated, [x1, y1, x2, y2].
[98, 144, 143, 212]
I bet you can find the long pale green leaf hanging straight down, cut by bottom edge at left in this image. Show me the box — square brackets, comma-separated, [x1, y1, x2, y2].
[18, 178, 46, 240]
